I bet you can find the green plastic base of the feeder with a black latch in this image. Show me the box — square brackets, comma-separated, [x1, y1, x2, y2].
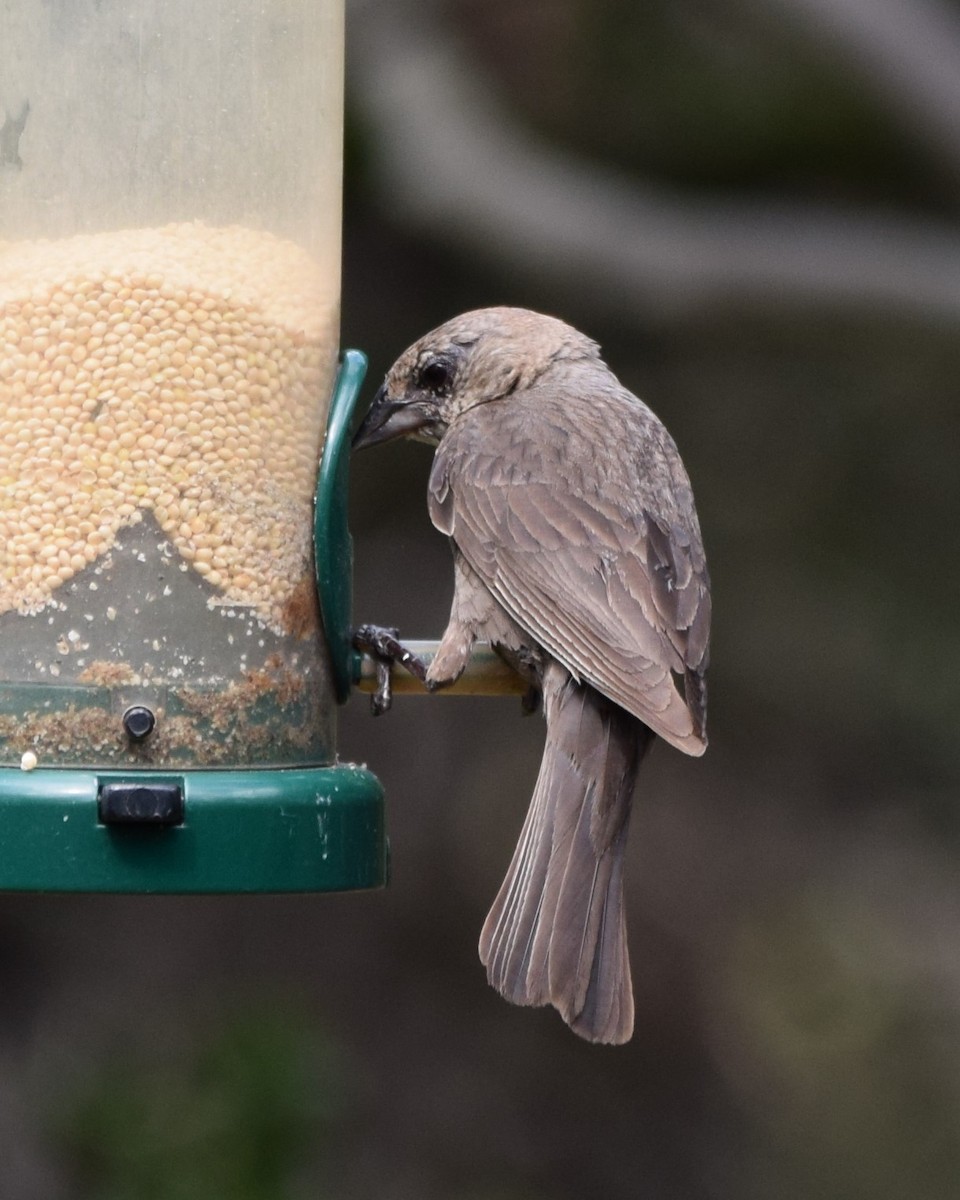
[0, 764, 386, 894]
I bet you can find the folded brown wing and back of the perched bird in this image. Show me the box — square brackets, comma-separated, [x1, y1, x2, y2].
[430, 392, 710, 754]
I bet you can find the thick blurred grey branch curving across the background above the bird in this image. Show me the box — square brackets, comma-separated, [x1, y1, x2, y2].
[348, 0, 960, 322]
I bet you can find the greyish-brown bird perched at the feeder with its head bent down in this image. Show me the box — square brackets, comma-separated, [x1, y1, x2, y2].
[354, 308, 710, 1043]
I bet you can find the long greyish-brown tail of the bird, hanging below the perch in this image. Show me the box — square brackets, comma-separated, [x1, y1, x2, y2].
[480, 662, 653, 1043]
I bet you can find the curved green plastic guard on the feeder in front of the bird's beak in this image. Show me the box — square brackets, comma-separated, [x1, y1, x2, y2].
[313, 350, 367, 704]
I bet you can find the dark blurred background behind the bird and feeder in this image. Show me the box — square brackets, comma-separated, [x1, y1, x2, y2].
[0, 0, 960, 1200]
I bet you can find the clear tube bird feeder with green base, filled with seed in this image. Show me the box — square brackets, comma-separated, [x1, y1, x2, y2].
[0, 0, 385, 892]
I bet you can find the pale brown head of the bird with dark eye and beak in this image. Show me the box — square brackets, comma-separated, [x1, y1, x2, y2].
[353, 308, 600, 449]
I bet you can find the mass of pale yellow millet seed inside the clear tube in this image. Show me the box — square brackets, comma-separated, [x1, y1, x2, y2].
[0, 223, 337, 628]
